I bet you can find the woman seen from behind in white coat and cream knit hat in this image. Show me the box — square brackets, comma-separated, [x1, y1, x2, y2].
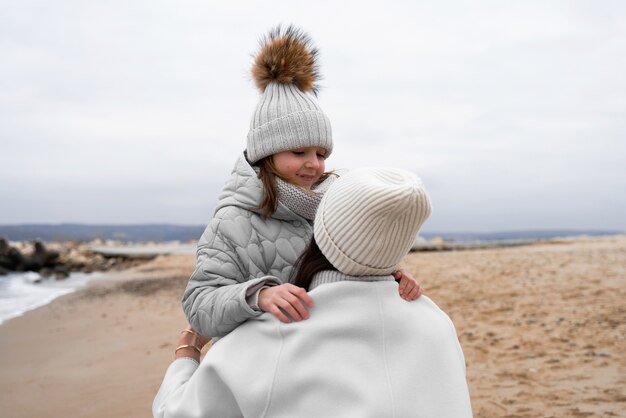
[153, 168, 472, 418]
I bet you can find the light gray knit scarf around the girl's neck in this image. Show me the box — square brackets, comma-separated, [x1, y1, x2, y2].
[276, 174, 337, 221]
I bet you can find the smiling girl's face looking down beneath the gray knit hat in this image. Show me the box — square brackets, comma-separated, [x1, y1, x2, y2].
[272, 147, 326, 190]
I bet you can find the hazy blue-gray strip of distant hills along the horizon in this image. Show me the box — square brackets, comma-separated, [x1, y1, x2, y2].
[0, 223, 624, 242]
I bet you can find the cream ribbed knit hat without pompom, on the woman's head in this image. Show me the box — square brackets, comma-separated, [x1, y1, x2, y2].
[314, 168, 431, 276]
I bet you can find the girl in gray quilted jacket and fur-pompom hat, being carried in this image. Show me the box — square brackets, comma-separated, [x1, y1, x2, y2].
[183, 27, 421, 337]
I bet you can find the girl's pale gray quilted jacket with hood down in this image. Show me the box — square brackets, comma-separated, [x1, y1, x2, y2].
[183, 155, 313, 337]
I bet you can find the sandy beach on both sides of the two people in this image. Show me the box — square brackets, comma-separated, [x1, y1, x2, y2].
[0, 236, 626, 418]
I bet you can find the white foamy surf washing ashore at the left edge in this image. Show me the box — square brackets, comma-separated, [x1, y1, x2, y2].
[0, 272, 104, 324]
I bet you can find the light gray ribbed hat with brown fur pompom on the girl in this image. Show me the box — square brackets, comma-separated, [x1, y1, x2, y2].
[246, 26, 333, 164]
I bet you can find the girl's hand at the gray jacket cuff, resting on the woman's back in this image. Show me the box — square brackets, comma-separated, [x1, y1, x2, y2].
[258, 283, 313, 322]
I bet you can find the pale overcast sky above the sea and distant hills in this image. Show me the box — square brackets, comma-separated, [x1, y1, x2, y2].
[0, 0, 626, 231]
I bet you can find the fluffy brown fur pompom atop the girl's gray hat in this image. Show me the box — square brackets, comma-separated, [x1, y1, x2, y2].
[252, 26, 320, 95]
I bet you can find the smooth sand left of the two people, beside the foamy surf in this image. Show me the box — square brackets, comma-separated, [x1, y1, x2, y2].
[0, 256, 195, 418]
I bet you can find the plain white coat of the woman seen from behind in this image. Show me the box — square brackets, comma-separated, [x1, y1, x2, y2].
[153, 277, 472, 418]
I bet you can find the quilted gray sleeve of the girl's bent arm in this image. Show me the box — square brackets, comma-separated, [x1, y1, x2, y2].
[183, 211, 281, 337]
